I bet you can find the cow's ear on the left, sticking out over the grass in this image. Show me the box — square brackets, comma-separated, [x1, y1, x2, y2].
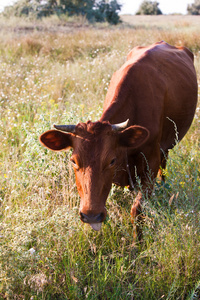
[39, 130, 73, 151]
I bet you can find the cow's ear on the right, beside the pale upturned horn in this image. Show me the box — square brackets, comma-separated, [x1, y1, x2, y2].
[119, 125, 149, 148]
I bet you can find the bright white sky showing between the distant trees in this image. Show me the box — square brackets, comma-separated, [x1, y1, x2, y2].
[0, 0, 194, 14]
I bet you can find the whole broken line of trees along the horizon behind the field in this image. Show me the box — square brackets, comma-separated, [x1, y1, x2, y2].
[4, 0, 200, 25]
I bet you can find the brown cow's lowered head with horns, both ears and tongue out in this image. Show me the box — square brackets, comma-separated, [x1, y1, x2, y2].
[40, 121, 149, 230]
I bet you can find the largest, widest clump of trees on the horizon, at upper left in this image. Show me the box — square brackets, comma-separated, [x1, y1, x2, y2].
[5, 0, 121, 25]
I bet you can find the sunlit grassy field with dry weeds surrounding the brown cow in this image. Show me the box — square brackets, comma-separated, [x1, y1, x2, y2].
[0, 16, 200, 300]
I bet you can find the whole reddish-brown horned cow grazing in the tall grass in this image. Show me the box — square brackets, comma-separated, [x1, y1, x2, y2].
[40, 41, 197, 240]
